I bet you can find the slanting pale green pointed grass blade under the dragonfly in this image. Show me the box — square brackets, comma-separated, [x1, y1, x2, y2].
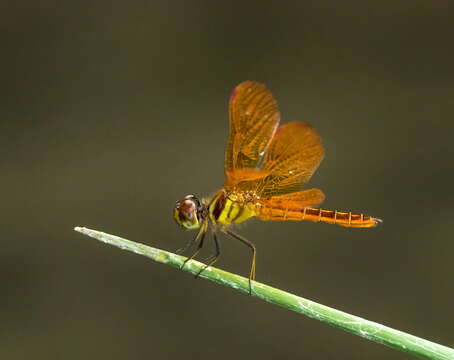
[74, 227, 454, 360]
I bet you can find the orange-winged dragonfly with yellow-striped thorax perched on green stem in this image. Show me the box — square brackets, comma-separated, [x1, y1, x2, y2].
[173, 81, 381, 294]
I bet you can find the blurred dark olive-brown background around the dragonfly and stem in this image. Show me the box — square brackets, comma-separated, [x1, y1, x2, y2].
[0, 0, 454, 359]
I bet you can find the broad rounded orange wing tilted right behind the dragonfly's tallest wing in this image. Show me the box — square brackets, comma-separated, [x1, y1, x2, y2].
[257, 122, 324, 198]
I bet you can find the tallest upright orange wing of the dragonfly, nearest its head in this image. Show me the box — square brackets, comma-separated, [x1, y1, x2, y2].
[225, 81, 279, 188]
